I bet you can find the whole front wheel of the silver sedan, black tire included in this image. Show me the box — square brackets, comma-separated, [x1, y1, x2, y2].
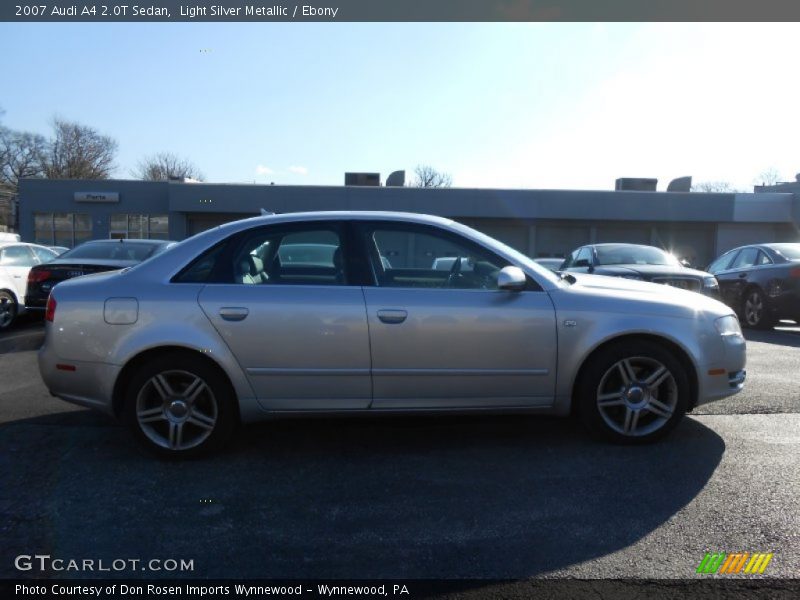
[574, 340, 691, 444]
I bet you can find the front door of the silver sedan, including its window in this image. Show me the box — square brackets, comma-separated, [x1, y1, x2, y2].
[358, 221, 556, 409]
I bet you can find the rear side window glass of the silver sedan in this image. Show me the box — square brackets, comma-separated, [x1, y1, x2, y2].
[175, 223, 347, 285]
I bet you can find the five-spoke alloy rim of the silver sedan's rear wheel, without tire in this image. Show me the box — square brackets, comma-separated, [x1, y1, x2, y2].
[136, 370, 219, 450]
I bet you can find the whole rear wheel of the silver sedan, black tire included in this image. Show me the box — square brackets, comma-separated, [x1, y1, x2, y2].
[122, 353, 239, 459]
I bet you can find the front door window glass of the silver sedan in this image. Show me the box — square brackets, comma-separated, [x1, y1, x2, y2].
[362, 224, 508, 290]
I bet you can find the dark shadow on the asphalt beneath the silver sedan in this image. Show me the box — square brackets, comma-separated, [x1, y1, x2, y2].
[0, 411, 725, 578]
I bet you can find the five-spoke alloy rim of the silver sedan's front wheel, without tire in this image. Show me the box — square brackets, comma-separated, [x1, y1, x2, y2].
[596, 356, 678, 437]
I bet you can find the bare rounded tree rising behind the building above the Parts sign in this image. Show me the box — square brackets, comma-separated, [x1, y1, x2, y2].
[42, 118, 117, 179]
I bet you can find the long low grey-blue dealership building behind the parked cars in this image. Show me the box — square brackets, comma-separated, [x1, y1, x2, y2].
[18, 179, 800, 265]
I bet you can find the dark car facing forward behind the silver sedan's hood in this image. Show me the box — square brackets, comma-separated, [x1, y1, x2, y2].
[560, 244, 719, 298]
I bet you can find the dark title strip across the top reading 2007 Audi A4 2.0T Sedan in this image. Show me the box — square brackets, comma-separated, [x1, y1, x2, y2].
[0, 0, 800, 23]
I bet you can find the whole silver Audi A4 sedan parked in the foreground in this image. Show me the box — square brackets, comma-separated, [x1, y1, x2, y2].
[39, 212, 745, 457]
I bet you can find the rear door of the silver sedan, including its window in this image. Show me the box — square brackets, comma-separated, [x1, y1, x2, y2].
[194, 221, 372, 410]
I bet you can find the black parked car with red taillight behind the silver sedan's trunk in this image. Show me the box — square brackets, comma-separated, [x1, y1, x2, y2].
[25, 240, 175, 310]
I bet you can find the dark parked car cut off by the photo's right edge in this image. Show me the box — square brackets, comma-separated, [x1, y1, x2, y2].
[708, 244, 800, 329]
